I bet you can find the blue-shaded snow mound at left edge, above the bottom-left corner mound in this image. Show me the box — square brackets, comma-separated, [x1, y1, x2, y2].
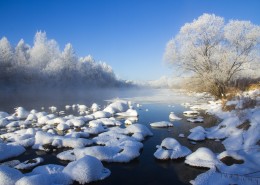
[0, 143, 25, 161]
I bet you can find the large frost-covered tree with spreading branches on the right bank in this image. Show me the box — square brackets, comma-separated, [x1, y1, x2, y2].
[164, 14, 260, 97]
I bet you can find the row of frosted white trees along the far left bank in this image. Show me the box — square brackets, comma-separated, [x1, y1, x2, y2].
[0, 32, 131, 88]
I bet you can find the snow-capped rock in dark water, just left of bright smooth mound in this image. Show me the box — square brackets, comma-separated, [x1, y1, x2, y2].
[154, 138, 191, 160]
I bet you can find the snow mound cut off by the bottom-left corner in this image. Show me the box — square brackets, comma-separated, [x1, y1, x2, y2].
[0, 165, 23, 185]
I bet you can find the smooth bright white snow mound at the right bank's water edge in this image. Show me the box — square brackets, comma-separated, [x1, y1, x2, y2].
[185, 147, 219, 168]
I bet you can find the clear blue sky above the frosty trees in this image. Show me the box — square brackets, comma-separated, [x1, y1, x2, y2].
[0, 0, 260, 80]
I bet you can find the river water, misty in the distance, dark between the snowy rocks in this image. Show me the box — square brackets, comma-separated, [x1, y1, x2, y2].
[0, 89, 223, 185]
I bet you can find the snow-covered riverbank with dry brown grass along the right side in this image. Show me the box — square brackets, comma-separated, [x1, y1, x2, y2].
[185, 90, 260, 185]
